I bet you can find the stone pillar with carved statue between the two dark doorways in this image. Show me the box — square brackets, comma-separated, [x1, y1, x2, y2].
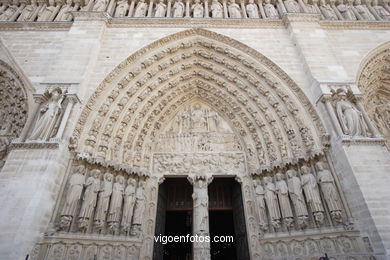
[188, 175, 213, 260]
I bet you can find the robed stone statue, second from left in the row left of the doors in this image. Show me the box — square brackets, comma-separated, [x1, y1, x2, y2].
[79, 169, 100, 230]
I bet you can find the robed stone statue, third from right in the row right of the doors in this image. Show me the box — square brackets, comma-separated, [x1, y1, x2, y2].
[286, 169, 309, 229]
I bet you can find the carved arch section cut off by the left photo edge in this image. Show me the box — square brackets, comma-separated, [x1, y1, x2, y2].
[0, 61, 27, 169]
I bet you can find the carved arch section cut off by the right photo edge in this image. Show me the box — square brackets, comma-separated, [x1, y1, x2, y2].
[358, 43, 390, 147]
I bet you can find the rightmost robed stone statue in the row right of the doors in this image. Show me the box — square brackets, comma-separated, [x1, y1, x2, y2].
[316, 162, 342, 222]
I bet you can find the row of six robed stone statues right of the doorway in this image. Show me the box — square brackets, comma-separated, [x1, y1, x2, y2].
[254, 162, 343, 232]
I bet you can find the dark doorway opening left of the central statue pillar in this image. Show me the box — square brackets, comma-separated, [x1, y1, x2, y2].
[153, 178, 192, 260]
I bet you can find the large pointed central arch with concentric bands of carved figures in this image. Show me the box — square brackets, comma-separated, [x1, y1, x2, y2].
[73, 29, 325, 171]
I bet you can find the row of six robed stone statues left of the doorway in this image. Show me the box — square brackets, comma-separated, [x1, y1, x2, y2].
[59, 165, 145, 235]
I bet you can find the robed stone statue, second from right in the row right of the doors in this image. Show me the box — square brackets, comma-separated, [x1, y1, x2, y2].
[301, 166, 324, 225]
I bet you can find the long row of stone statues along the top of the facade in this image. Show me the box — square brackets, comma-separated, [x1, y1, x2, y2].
[0, 0, 390, 22]
